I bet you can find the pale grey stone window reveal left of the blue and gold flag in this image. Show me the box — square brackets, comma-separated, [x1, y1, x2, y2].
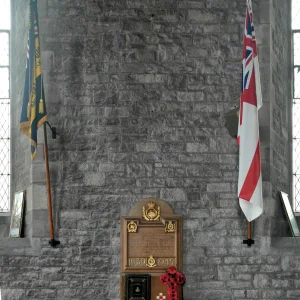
[10, 1, 31, 199]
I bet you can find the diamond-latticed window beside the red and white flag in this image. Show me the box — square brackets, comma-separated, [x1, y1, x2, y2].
[292, 0, 300, 212]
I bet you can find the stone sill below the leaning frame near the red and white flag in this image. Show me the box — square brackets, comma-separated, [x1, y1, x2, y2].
[271, 237, 300, 255]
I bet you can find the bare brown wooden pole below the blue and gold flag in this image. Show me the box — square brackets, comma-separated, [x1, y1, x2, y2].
[44, 122, 60, 247]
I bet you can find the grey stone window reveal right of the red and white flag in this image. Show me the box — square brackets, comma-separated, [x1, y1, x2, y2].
[270, 0, 293, 233]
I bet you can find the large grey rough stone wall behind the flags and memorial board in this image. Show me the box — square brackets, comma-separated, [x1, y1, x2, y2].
[0, 0, 300, 300]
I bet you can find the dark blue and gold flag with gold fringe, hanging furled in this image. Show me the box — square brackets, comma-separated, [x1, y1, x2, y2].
[20, 0, 47, 159]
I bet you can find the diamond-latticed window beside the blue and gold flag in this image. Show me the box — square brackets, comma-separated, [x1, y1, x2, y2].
[0, 0, 10, 213]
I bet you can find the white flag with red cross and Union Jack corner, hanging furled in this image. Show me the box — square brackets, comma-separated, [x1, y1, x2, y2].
[237, 0, 263, 222]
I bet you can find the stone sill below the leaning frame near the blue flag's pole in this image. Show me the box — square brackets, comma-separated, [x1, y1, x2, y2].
[0, 237, 41, 256]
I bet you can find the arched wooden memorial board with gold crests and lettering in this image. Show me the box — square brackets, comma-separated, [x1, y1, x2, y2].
[121, 198, 182, 300]
